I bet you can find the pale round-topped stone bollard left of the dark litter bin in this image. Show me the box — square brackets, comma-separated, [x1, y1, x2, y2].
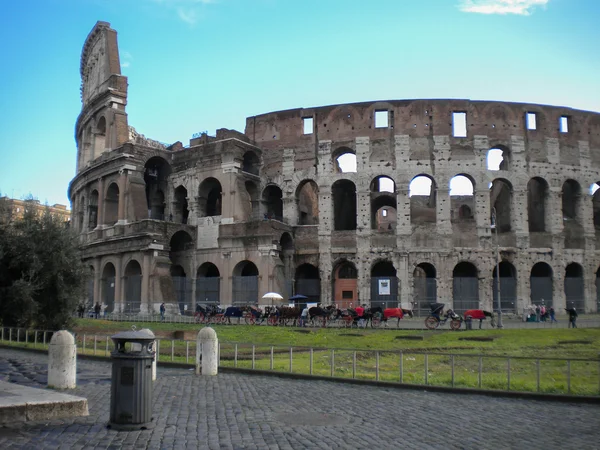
[48, 330, 77, 389]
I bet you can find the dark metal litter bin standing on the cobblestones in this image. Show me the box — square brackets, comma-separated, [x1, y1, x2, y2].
[108, 329, 156, 431]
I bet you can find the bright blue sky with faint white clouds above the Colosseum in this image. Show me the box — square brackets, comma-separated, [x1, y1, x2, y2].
[0, 0, 600, 204]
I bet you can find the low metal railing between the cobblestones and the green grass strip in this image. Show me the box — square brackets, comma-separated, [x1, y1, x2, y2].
[0, 328, 600, 396]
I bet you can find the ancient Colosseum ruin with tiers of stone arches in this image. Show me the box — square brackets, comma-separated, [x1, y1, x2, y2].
[69, 22, 600, 314]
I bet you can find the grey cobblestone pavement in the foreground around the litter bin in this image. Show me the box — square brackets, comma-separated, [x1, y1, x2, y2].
[0, 349, 600, 450]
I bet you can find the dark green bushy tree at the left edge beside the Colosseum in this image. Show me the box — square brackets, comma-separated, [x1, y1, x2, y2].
[0, 203, 88, 330]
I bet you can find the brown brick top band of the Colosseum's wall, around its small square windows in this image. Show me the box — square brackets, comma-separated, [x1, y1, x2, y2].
[245, 100, 600, 164]
